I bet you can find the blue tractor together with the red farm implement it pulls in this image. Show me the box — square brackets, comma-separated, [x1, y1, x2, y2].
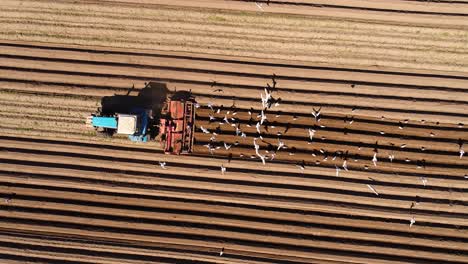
[86, 83, 196, 155]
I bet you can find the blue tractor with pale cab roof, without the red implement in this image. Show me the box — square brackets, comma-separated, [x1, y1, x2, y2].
[86, 109, 152, 142]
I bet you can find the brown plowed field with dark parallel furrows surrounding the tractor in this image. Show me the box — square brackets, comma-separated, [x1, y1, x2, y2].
[0, 0, 468, 264]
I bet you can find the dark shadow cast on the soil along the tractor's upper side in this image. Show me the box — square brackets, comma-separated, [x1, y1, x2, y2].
[100, 82, 169, 139]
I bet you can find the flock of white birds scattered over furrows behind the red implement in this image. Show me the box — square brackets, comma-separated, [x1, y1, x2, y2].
[154, 75, 468, 237]
